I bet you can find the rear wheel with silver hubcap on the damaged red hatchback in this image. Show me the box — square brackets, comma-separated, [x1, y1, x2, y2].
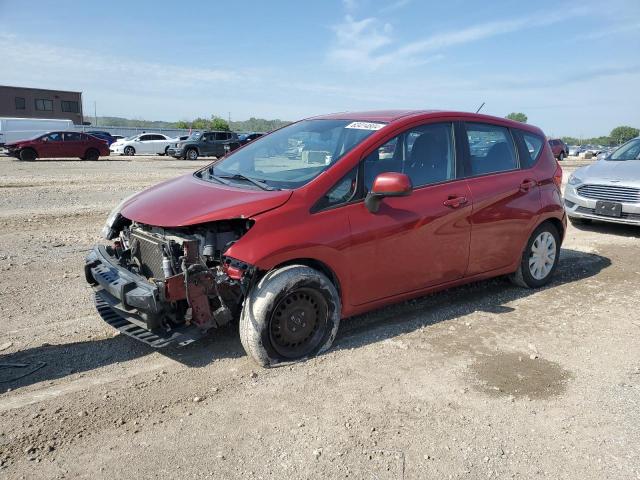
[511, 222, 560, 288]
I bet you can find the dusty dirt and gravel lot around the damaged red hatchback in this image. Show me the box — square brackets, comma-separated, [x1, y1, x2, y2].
[0, 157, 640, 479]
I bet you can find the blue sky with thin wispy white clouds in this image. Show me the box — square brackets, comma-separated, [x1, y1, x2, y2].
[0, 0, 640, 136]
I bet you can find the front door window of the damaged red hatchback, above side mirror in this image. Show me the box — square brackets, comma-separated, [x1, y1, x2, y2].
[364, 123, 456, 191]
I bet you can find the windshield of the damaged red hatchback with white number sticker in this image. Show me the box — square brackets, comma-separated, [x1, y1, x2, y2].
[198, 120, 385, 188]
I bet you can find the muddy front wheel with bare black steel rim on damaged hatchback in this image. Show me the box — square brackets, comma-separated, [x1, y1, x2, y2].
[240, 265, 342, 367]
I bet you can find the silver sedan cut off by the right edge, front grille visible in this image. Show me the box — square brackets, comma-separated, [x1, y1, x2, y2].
[564, 137, 640, 225]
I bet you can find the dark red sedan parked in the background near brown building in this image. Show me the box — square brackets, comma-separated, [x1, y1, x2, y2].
[5, 132, 109, 161]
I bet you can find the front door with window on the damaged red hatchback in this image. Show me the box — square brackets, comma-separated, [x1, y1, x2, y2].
[343, 122, 472, 305]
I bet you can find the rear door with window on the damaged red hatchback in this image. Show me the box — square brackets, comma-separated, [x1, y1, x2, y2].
[464, 123, 541, 276]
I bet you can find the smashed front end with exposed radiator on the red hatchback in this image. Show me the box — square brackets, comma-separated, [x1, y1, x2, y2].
[85, 219, 255, 347]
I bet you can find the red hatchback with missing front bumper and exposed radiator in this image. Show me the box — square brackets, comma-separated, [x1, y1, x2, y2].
[85, 111, 566, 366]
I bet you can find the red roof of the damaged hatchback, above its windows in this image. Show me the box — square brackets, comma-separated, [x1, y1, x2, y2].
[311, 110, 541, 132]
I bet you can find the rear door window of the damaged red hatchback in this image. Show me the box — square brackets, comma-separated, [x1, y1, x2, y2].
[466, 123, 518, 175]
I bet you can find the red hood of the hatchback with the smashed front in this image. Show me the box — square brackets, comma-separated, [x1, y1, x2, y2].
[120, 173, 292, 227]
